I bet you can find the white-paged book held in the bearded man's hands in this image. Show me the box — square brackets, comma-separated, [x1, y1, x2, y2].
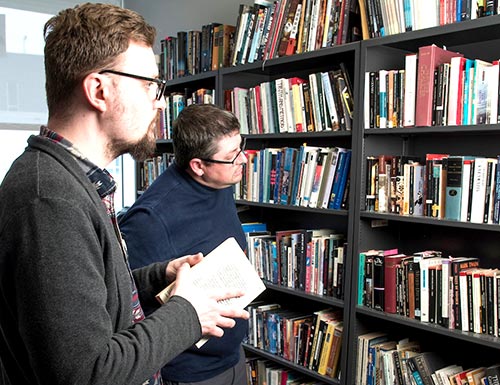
[156, 237, 266, 347]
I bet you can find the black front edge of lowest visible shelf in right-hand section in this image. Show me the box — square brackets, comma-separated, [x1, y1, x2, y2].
[356, 306, 500, 350]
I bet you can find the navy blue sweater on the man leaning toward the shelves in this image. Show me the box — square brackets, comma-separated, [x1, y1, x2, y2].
[120, 164, 247, 382]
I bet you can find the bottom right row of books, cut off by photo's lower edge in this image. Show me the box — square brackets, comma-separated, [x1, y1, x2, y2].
[355, 331, 500, 385]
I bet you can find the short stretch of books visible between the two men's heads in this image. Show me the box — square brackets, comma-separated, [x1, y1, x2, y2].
[160, 88, 215, 139]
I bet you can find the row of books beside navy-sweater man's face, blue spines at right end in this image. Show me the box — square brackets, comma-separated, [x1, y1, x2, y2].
[235, 144, 351, 210]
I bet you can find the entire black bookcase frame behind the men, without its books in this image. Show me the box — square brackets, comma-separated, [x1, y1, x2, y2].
[138, 5, 500, 385]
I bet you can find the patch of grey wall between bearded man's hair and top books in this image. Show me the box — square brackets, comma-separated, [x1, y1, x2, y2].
[123, 0, 242, 53]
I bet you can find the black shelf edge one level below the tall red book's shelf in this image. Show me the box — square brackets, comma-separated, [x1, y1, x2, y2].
[360, 211, 500, 232]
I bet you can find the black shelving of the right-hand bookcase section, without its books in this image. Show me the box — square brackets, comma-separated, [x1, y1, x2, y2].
[347, 16, 500, 383]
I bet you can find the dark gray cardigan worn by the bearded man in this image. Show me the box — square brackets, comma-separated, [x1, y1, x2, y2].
[0, 136, 201, 385]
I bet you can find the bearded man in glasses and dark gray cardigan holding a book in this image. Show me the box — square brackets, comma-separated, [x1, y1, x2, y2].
[0, 3, 248, 385]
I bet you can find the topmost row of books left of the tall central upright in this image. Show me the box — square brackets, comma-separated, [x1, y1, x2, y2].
[160, 0, 361, 80]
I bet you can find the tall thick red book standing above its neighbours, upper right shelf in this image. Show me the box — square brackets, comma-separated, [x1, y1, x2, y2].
[415, 44, 463, 126]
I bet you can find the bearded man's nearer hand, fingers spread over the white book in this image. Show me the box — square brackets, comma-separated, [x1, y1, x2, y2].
[172, 262, 249, 337]
